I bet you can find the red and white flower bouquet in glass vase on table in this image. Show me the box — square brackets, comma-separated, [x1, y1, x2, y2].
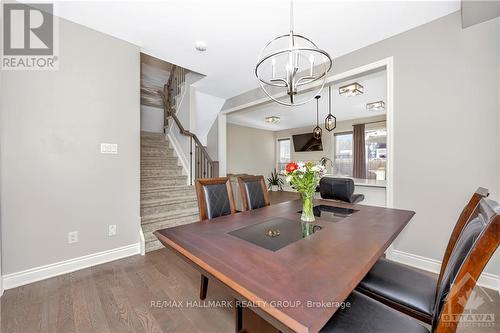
[283, 162, 326, 222]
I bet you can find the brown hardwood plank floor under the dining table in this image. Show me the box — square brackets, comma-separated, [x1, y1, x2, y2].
[0, 193, 500, 333]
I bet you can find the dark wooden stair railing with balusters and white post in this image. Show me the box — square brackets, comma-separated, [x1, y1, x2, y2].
[158, 65, 219, 185]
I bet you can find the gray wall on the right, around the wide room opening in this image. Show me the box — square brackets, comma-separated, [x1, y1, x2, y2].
[223, 12, 500, 274]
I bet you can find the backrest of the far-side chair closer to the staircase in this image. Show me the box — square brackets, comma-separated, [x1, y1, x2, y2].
[196, 177, 236, 220]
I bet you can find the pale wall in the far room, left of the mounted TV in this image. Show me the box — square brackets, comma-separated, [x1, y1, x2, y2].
[226, 123, 275, 178]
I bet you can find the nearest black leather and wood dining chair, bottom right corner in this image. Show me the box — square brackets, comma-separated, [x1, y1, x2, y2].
[320, 198, 500, 333]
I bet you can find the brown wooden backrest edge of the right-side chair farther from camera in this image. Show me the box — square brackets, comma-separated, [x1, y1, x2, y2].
[436, 187, 489, 294]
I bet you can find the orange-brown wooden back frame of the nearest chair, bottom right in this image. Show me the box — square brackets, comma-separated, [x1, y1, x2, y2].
[435, 199, 500, 333]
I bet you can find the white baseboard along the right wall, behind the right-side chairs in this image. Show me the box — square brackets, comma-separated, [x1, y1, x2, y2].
[387, 249, 500, 293]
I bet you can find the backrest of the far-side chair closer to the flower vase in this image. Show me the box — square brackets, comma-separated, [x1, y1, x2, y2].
[238, 176, 270, 210]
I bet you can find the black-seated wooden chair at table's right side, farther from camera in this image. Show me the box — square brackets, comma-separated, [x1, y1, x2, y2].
[356, 188, 488, 324]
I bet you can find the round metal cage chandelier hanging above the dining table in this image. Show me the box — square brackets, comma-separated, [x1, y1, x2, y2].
[255, 0, 333, 106]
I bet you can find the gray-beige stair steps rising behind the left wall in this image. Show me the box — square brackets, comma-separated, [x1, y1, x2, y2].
[141, 132, 199, 252]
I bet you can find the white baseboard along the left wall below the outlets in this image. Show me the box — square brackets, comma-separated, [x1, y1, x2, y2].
[2, 243, 140, 290]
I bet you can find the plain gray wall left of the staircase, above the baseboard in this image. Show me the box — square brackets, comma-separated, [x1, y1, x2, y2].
[0, 20, 140, 274]
